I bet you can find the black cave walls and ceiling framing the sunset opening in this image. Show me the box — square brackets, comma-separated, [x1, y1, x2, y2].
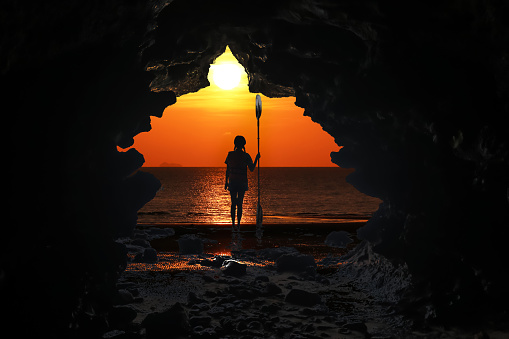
[0, 0, 509, 337]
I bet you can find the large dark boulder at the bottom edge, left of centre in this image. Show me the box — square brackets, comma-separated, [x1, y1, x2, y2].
[141, 303, 191, 339]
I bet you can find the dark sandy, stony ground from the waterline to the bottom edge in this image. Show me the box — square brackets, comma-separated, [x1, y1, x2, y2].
[110, 222, 507, 338]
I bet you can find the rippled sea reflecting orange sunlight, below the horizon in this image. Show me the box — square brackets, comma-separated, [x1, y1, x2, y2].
[138, 167, 381, 224]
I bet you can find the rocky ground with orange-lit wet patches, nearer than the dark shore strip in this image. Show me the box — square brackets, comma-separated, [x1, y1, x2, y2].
[103, 226, 507, 339]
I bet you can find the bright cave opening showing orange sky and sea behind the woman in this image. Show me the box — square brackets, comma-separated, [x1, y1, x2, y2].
[127, 46, 380, 257]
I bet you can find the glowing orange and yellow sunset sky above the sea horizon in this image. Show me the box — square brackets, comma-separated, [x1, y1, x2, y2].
[129, 48, 339, 167]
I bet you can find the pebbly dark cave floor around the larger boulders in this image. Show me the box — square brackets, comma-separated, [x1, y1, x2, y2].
[115, 225, 509, 338]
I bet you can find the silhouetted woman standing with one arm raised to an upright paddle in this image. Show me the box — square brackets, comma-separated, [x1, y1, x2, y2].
[224, 135, 260, 226]
